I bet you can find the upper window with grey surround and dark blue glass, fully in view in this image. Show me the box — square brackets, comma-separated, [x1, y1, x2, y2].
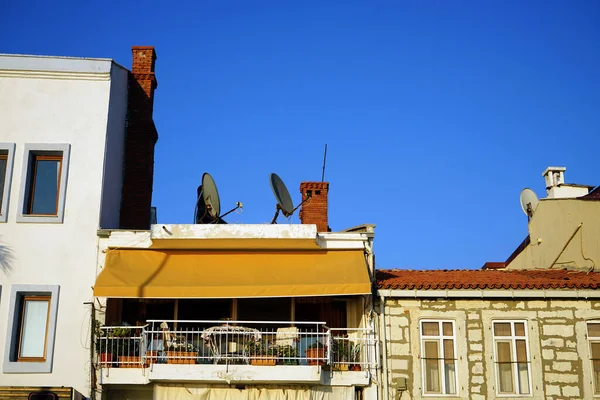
[17, 144, 70, 223]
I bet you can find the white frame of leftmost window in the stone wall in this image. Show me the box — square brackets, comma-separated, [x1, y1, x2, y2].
[419, 319, 460, 397]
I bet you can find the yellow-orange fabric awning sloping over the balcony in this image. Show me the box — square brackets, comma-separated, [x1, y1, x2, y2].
[94, 249, 371, 298]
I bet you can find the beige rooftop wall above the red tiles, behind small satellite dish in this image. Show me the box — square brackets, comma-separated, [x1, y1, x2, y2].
[507, 199, 600, 270]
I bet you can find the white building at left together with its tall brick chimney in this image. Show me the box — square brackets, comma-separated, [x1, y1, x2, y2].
[0, 47, 157, 398]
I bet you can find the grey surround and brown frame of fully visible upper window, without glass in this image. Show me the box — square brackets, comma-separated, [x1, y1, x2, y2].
[17, 143, 71, 223]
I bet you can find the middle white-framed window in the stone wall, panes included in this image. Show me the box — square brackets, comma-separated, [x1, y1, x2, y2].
[492, 321, 531, 395]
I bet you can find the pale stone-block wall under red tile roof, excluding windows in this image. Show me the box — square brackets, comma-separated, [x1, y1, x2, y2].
[383, 299, 600, 400]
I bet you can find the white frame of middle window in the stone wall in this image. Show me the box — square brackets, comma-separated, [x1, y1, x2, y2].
[492, 319, 533, 397]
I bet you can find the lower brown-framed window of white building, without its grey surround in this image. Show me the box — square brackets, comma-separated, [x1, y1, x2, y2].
[17, 296, 50, 361]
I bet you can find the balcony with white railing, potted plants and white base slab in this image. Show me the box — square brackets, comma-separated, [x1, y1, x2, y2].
[96, 320, 376, 385]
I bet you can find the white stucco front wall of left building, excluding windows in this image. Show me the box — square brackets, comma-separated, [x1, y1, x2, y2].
[0, 56, 123, 395]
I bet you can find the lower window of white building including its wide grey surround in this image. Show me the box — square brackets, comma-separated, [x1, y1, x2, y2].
[3, 285, 59, 373]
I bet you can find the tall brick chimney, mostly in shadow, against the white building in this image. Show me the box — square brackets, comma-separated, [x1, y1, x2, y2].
[120, 46, 158, 229]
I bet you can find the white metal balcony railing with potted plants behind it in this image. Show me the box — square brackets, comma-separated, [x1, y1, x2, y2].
[96, 320, 375, 371]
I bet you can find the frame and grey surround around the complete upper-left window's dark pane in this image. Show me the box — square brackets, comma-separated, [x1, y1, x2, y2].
[17, 143, 71, 224]
